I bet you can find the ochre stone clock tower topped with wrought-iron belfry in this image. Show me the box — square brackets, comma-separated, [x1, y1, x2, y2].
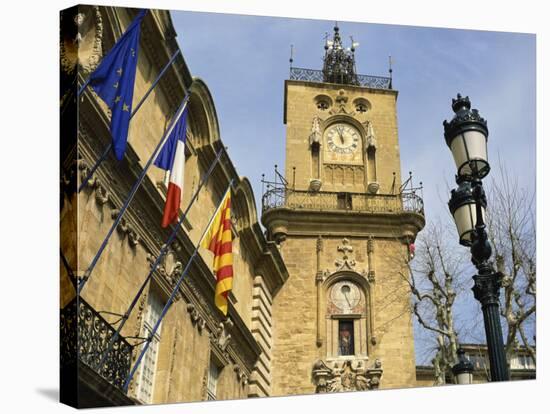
[262, 27, 424, 395]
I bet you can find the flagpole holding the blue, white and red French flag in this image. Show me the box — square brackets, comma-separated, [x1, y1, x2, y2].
[77, 94, 189, 295]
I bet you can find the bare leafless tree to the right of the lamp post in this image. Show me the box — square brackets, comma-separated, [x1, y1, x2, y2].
[487, 163, 537, 364]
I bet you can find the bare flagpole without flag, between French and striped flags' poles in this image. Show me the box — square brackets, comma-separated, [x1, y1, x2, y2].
[96, 148, 223, 368]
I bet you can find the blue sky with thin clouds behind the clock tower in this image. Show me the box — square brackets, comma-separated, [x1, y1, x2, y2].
[172, 11, 536, 362]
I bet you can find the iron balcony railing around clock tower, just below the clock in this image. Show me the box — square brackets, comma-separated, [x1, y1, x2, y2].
[262, 187, 424, 215]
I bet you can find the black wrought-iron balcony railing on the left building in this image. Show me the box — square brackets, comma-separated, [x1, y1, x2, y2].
[60, 298, 132, 389]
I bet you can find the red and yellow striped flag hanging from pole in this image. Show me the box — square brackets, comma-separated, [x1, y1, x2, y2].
[201, 190, 233, 315]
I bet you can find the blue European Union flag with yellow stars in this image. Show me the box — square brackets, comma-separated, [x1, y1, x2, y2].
[89, 10, 147, 160]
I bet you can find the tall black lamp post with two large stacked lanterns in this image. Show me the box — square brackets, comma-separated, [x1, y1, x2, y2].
[443, 94, 509, 381]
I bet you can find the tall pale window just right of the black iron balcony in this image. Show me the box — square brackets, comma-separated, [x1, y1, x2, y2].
[137, 290, 164, 403]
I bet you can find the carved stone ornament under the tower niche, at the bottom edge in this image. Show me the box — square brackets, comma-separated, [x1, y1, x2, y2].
[312, 359, 383, 393]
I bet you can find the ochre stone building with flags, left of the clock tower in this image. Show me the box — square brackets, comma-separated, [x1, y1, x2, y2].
[60, 6, 288, 407]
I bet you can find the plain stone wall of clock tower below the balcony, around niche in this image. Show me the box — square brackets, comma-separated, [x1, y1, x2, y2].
[273, 236, 416, 395]
